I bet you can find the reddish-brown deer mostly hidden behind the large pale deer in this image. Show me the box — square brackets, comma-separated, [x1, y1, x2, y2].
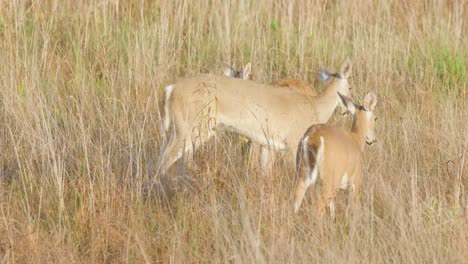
[223, 62, 318, 174]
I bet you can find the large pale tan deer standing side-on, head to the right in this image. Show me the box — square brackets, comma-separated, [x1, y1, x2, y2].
[161, 60, 351, 175]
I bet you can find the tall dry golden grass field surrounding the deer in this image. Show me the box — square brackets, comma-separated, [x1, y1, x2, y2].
[0, 0, 468, 263]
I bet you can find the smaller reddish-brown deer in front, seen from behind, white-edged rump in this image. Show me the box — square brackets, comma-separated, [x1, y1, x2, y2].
[294, 92, 377, 219]
